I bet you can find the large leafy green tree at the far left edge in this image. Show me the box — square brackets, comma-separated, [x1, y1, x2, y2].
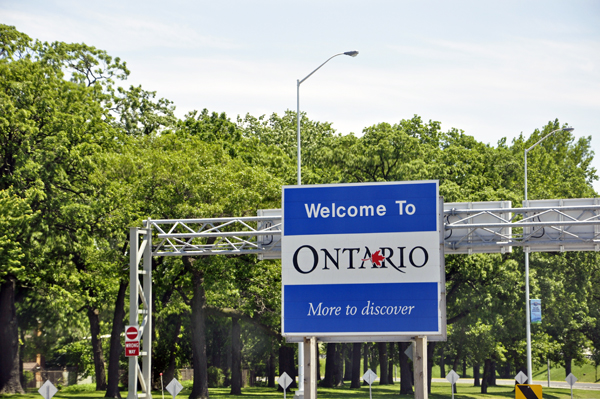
[0, 25, 126, 391]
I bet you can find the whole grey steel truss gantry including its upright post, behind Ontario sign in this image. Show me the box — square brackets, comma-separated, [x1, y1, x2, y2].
[127, 198, 600, 399]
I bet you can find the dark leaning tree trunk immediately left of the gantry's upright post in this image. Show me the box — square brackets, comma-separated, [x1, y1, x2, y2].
[104, 280, 129, 399]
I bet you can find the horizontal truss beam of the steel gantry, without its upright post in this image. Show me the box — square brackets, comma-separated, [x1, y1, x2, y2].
[146, 199, 600, 258]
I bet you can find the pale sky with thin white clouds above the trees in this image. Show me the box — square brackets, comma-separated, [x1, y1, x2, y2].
[0, 0, 600, 193]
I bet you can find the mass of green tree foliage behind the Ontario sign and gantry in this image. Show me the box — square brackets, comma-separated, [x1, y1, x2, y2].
[0, 25, 600, 396]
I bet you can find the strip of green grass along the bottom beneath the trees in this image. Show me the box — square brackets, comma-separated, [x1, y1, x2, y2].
[0, 381, 600, 399]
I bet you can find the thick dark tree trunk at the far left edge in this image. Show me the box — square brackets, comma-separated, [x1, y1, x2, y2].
[0, 276, 25, 394]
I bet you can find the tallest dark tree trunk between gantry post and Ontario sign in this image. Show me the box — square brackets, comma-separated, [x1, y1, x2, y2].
[191, 266, 208, 399]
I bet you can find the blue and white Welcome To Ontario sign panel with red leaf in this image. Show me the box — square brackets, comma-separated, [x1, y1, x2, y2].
[281, 181, 443, 337]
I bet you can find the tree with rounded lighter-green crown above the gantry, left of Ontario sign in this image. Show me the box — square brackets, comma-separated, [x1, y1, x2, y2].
[112, 131, 279, 398]
